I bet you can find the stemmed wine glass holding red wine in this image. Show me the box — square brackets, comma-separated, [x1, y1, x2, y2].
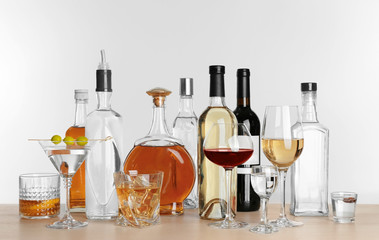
[203, 123, 254, 229]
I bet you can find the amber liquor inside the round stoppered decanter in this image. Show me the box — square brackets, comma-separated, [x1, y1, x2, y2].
[124, 145, 195, 215]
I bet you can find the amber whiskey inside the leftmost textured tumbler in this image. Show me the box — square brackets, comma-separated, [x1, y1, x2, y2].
[20, 198, 60, 217]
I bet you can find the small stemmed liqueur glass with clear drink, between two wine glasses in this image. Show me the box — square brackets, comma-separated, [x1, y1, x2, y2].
[250, 166, 278, 234]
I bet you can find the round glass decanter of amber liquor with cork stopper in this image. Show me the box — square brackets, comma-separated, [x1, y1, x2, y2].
[124, 88, 195, 215]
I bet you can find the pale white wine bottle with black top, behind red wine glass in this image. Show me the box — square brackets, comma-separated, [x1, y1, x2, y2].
[197, 65, 237, 219]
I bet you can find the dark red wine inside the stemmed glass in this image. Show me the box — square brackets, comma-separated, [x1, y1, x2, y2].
[204, 148, 253, 170]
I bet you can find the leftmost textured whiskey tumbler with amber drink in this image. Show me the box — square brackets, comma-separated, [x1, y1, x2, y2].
[19, 173, 60, 219]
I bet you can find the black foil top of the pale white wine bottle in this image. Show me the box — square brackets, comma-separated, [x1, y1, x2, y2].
[209, 65, 225, 97]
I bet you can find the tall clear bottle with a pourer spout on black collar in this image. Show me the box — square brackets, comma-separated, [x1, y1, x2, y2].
[86, 50, 123, 220]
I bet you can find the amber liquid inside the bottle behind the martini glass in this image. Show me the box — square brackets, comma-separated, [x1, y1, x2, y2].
[66, 127, 86, 208]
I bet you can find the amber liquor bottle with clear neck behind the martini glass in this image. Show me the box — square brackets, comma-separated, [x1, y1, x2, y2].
[66, 89, 88, 212]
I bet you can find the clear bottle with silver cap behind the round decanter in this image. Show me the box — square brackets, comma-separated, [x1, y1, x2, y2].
[173, 78, 199, 208]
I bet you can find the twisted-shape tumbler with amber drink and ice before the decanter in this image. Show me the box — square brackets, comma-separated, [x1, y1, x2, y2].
[113, 171, 163, 228]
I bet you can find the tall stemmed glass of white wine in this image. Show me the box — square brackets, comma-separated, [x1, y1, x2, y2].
[262, 106, 304, 227]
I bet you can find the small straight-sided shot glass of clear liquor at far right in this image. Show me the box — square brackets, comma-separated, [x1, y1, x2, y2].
[331, 192, 358, 223]
